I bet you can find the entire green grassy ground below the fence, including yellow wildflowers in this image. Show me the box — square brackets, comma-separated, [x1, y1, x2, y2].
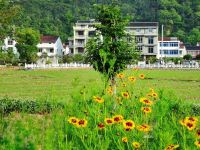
[0, 69, 200, 150]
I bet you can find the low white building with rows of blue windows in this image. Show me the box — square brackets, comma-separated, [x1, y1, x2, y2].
[156, 37, 186, 59]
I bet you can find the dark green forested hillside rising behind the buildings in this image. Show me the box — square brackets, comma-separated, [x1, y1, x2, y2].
[15, 0, 200, 44]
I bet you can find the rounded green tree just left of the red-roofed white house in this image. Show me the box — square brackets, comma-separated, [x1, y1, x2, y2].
[16, 28, 40, 63]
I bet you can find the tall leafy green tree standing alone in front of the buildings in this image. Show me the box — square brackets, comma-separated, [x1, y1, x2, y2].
[86, 4, 137, 89]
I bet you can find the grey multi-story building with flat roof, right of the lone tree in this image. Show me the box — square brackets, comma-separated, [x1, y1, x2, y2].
[126, 22, 158, 60]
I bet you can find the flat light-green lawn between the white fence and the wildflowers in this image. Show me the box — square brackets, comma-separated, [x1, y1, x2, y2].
[0, 69, 200, 101]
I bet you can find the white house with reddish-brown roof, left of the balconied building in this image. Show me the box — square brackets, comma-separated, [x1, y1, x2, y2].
[37, 36, 64, 64]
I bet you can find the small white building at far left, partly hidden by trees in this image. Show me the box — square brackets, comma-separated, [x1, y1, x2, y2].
[2, 37, 17, 54]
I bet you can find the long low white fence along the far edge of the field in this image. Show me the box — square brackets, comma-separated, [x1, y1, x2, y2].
[25, 63, 200, 69]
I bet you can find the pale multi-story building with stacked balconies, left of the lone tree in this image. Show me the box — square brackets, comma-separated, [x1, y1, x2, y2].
[68, 20, 98, 54]
